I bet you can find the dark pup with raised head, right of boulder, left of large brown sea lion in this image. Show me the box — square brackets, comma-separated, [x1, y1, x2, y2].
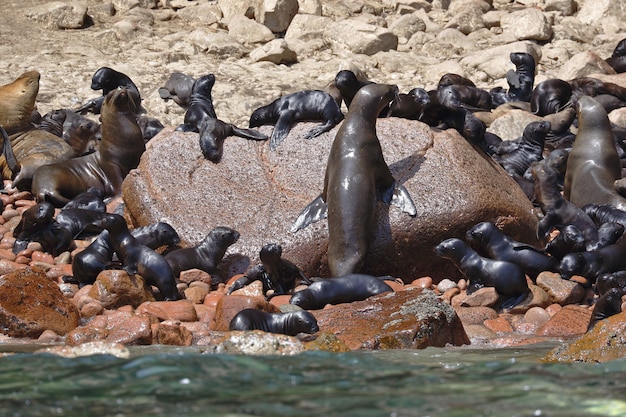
[492, 121, 550, 175]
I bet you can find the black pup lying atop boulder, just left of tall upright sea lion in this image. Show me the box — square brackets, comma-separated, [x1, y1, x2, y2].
[249, 90, 344, 150]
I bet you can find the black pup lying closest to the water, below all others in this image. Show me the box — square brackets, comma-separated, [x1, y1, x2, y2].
[228, 308, 319, 336]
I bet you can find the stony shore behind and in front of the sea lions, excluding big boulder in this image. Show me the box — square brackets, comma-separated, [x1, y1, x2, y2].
[0, 0, 626, 360]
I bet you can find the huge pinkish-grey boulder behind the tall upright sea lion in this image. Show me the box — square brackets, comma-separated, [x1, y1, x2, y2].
[123, 118, 537, 282]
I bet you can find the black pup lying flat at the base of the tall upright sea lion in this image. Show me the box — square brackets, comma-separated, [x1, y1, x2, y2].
[289, 274, 393, 310]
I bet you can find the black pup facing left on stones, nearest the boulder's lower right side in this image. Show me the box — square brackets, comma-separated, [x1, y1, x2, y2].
[435, 238, 529, 309]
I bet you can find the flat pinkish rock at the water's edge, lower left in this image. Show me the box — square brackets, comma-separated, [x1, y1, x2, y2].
[65, 311, 152, 346]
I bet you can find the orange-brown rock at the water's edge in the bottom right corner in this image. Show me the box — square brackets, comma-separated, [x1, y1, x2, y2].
[542, 312, 626, 362]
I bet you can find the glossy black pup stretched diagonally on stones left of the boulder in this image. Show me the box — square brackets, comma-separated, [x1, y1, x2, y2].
[88, 214, 182, 301]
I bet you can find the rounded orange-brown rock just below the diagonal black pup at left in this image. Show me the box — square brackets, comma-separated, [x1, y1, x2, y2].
[89, 269, 154, 310]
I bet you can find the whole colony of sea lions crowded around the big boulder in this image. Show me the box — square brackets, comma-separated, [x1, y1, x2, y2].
[0, 36, 626, 334]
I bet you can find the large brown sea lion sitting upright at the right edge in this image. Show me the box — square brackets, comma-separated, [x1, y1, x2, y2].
[563, 95, 626, 210]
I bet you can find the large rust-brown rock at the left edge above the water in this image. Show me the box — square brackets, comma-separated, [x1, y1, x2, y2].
[0, 268, 79, 338]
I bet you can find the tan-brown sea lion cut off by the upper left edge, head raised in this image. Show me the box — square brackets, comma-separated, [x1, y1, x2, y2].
[0, 71, 41, 135]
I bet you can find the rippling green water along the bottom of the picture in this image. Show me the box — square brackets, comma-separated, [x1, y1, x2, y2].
[0, 348, 626, 417]
